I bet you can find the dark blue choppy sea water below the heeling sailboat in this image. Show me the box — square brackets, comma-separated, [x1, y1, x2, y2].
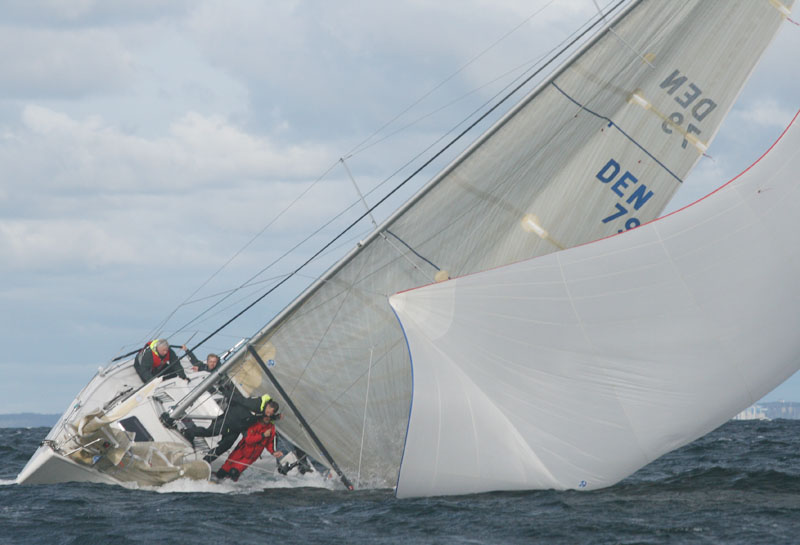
[0, 420, 800, 545]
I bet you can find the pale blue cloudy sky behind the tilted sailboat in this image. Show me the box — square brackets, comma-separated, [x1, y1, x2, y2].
[0, 0, 800, 413]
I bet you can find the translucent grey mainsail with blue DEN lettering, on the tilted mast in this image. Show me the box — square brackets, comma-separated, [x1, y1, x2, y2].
[177, 0, 791, 487]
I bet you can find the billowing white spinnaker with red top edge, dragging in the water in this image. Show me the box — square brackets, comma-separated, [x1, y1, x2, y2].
[391, 113, 800, 497]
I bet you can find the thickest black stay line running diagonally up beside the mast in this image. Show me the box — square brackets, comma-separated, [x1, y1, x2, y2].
[192, 0, 625, 350]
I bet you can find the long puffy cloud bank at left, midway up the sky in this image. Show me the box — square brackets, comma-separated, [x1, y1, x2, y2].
[0, 106, 335, 214]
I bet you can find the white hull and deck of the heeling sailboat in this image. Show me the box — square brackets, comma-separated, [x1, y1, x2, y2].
[17, 360, 222, 486]
